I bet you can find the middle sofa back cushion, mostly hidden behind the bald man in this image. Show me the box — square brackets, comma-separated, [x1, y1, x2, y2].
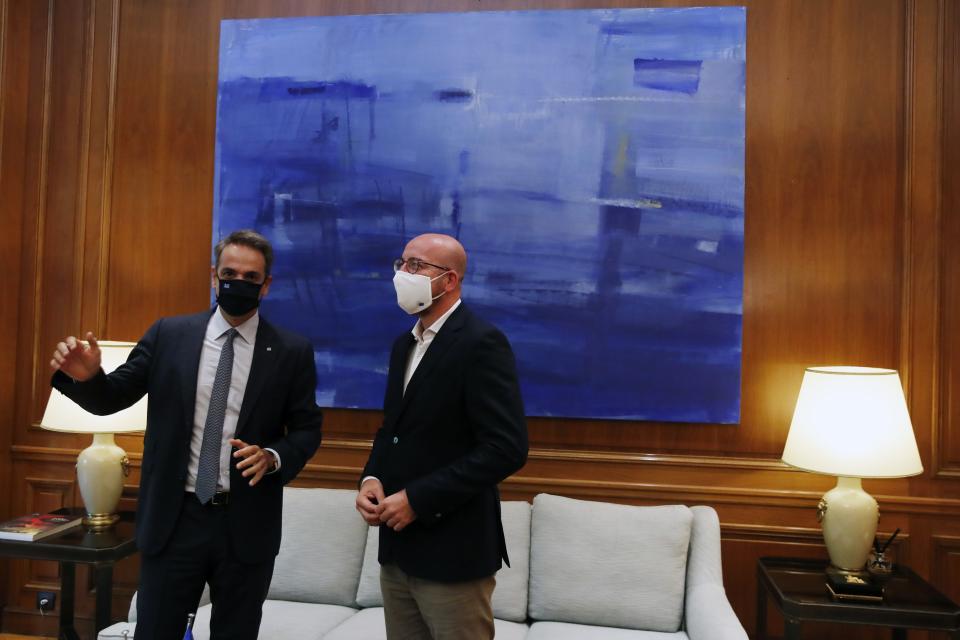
[356, 501, 530, 622]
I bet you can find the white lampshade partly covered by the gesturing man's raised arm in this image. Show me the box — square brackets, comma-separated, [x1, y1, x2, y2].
[40, 340, 147, 433]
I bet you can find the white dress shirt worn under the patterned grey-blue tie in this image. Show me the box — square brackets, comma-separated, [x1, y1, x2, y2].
[185, 307, 280, 491]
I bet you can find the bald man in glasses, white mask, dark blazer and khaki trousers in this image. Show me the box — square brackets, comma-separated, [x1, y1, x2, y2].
[356, 234, 527, 640]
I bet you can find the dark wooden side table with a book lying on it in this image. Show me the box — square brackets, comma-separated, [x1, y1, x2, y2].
[0, 512, 137, 640]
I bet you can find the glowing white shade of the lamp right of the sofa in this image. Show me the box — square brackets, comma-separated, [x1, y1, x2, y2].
[783, 367, 923, 478]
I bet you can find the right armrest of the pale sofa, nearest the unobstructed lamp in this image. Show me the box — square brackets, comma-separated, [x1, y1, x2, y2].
[684, 506, 747, 640]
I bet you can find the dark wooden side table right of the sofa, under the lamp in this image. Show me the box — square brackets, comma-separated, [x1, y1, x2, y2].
[757, 558, 960, 640]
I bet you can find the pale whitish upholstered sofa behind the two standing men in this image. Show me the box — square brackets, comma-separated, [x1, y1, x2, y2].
[98, 487, 747, 640]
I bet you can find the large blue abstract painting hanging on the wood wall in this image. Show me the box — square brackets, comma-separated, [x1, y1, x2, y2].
[214, 7, 746, 423]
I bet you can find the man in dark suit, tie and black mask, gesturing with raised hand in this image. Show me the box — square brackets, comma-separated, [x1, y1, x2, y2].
[50, 230, 322, 640]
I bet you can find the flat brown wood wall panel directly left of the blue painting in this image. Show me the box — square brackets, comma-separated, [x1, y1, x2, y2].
[106, 1, 219, 339]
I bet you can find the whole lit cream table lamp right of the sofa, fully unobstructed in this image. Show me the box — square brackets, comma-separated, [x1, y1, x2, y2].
[783, 367, 923, 572]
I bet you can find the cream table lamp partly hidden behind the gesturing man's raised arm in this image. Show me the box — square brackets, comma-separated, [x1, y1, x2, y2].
[40, 340, 147, 530]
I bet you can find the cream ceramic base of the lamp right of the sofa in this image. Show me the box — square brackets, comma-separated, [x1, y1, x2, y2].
[817, 476, 880, 573]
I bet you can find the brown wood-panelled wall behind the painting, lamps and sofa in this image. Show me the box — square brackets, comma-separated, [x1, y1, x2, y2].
[0, 0, 960, 638]
